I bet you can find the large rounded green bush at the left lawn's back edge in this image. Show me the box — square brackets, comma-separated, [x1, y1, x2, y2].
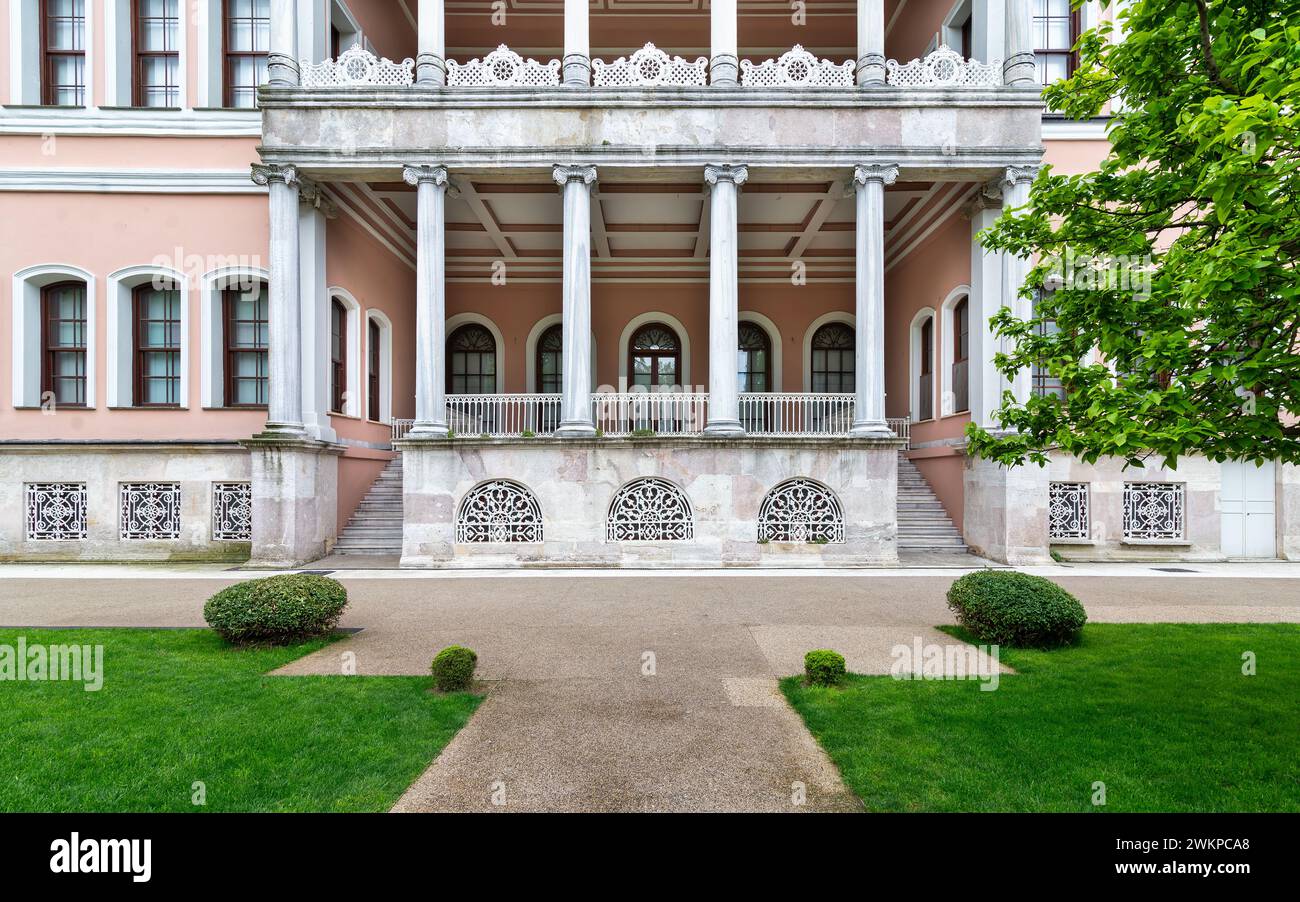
[203, 573, 347, 645]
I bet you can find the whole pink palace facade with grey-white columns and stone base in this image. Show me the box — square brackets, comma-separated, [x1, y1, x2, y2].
[0, 0, 1300, 567]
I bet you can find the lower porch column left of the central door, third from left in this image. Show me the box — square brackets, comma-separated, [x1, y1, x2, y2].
[553, 165, 595, 438]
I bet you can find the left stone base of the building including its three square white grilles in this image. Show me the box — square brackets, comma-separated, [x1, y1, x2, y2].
[0, 441, 251, 561]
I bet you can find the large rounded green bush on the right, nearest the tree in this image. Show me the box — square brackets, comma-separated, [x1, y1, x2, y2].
[948, 571, 1088, 649]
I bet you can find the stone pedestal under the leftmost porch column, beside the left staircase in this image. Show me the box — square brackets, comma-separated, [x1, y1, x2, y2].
[242, 433, 343, 567]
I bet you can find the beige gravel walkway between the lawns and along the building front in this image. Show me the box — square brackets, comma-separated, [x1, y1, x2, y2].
[0, 565, 1300, 811]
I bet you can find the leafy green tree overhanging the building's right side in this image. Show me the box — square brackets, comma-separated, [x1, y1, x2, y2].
[967, 0, 1300, 467]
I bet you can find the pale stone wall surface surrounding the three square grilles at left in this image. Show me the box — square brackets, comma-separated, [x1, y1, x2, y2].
[0, 442, 251, 561]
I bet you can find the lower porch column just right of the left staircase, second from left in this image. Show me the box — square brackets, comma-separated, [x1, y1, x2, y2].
[402, 165, 447, 438]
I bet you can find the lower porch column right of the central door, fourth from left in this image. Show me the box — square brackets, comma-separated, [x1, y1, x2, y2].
[705, 165, 749, 435]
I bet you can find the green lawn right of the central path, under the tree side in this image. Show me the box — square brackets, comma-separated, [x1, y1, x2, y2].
[781, 624, 1300, 811]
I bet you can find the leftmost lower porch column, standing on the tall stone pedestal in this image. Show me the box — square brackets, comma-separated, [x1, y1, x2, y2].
[252, 165, 304, 435]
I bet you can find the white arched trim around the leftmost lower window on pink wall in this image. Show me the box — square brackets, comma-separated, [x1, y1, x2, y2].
[10, 263, 98, 409]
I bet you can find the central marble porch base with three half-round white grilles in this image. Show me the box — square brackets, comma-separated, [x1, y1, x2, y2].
[399, 437, 901, 568]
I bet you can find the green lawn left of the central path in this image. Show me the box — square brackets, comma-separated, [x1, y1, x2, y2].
[0, 629, 480, 811]
